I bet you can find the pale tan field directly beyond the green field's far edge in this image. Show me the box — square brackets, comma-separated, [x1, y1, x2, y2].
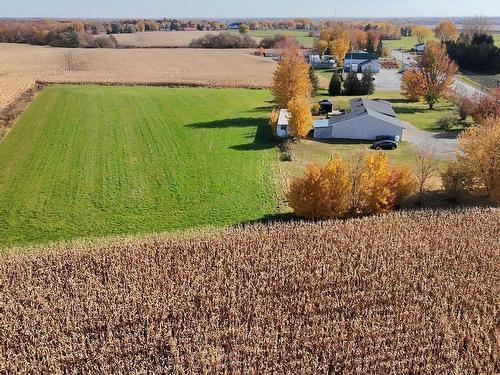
[0, 44, 276, 108]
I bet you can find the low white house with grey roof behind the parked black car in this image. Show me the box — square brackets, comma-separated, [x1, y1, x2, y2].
[314, 99, 405, 141]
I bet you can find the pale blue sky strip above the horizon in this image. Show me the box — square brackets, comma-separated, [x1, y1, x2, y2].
[0, 0, 500, 18]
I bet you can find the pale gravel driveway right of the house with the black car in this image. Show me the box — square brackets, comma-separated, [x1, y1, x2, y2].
[403, 122, 458, 159]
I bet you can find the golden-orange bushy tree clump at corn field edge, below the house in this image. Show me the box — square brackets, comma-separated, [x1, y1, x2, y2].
[287, 152, 416, 219]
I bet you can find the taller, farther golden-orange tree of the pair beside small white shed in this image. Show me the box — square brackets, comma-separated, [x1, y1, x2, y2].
[271, 47, 312, 108]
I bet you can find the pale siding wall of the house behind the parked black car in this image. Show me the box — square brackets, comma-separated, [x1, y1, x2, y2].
[332, 116, 403, 140]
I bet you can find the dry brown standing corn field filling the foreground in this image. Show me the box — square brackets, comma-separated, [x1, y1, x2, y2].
[0, 209, 500, 374]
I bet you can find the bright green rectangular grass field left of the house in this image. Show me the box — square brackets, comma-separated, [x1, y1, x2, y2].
[0, 86, 277, 247]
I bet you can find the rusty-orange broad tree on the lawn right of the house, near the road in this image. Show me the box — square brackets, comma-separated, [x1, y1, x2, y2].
[401, 43, 458, 109]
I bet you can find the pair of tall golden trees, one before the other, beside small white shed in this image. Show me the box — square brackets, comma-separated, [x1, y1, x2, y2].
[272, 42, 313, 138]
